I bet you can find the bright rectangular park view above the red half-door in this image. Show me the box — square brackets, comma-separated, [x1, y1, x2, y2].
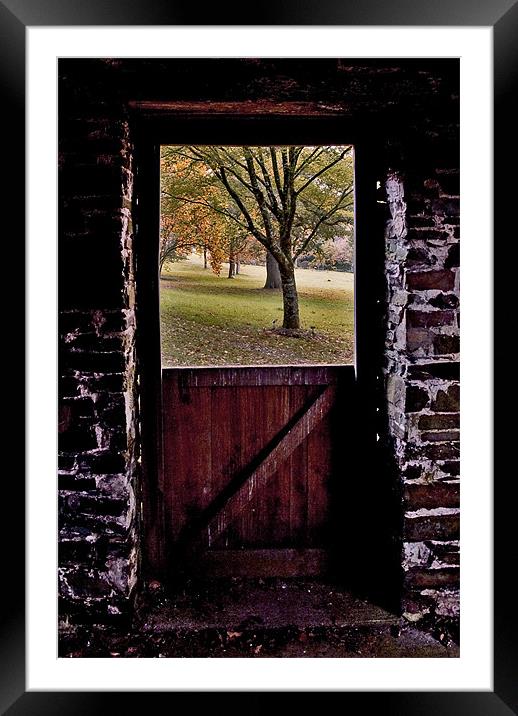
[159, 145, 355, 367]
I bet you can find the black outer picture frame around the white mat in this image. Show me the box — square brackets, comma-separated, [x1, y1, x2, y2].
[5, 0, 518, 716]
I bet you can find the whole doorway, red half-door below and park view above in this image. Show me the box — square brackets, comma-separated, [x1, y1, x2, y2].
[133, 116, 392, 640]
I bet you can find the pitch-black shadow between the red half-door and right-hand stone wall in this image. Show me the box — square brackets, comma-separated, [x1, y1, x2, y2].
[327, 372, 402, 613]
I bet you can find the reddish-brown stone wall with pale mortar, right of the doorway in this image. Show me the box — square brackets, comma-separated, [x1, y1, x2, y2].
[385, 112, 460, 624]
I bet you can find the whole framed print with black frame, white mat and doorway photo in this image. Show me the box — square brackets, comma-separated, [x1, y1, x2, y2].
[4, 0, 517, 714]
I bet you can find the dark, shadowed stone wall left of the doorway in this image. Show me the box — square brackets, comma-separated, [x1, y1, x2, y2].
[58, 114, 140, 621]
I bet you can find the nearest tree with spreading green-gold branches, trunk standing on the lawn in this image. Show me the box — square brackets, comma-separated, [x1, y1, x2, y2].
[166, 146, 353, 329]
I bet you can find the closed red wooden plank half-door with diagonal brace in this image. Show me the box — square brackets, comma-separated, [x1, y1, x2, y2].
[162, 366, 354, 577]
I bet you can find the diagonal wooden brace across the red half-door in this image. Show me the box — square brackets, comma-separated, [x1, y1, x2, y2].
[177, 385, 336, 548]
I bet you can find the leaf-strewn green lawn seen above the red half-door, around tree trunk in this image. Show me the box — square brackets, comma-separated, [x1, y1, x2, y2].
[160, 256, 354, 366]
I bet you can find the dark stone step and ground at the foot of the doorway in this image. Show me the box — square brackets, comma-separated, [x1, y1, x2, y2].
[60, 578, 458, 658]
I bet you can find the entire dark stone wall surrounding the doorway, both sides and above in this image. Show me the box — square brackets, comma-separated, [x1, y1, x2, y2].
[59, 58, 460, 636]
